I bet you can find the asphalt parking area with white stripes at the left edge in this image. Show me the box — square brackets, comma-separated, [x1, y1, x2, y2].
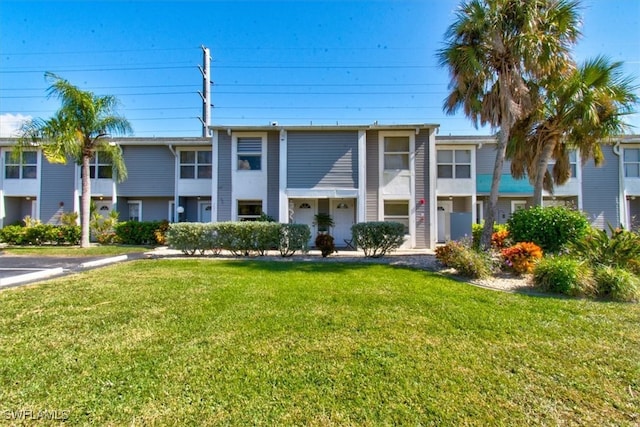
[0, 254, 143, 289]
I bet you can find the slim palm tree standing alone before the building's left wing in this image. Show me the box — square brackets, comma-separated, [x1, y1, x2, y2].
[16, 72, 132, 247]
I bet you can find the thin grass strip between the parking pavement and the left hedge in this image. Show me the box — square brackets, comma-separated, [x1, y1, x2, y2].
[0, 245, 152, 257]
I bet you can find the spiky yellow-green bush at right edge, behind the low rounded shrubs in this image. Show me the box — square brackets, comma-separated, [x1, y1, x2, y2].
[570, 225, 640, 274]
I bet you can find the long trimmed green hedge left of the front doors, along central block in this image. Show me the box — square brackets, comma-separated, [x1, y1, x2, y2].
[166, 221, 311, 257]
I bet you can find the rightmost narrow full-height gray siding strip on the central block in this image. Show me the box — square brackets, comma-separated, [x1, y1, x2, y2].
[415, 131, 435, 248]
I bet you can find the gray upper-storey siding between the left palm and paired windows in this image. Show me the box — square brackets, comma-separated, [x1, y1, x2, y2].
[118, 145, 175, 197]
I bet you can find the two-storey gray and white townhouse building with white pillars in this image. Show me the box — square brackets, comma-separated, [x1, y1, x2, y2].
[0, 123, 640, 248]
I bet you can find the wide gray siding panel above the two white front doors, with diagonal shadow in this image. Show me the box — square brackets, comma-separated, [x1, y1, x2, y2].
[287, 131, 358, 188]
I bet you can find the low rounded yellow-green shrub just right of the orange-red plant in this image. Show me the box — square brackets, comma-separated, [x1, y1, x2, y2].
[533, 255, 597, 296]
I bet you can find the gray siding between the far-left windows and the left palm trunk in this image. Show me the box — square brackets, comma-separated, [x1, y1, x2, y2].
[40, 159, 75, 223]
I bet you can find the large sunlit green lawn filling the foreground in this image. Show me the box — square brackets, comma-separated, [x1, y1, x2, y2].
[0, 259, 640, 426]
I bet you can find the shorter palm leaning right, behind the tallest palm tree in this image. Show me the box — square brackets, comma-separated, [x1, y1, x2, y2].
[507, 56, 638, 206]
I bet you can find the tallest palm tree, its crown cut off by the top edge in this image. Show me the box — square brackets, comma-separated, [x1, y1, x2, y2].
[438, 0, 580, 248]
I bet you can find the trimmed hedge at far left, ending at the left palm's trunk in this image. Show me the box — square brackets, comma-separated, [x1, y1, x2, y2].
[0, 224, 81, 245]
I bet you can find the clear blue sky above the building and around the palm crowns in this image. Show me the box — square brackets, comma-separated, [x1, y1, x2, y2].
[0, 0, 640, 137]
